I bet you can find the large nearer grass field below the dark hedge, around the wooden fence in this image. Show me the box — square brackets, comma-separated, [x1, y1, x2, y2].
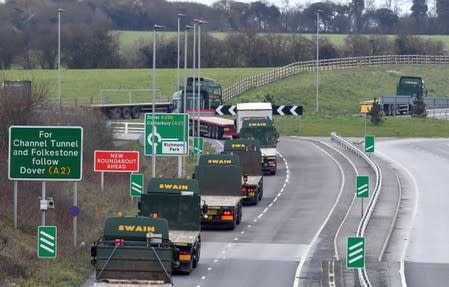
[3, 65, 449, 136]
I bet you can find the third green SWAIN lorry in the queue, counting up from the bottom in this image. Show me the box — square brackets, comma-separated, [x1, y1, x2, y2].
[194, 155, 242, 229]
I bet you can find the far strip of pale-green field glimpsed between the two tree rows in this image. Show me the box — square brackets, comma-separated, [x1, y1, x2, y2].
[112, 31, 449, 49]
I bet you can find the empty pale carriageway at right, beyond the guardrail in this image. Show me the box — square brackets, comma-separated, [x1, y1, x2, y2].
[376, 139, 449, 287]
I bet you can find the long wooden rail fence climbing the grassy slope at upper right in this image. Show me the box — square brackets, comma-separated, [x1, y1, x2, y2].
[223, 55, 449, 101]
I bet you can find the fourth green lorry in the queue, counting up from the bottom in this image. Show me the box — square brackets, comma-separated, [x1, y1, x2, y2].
[223, 139, 263, 205]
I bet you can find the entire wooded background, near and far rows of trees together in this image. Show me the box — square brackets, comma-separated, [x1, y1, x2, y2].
[0, 0, 449, 69]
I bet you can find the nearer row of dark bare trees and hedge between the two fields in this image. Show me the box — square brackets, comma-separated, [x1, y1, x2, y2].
[0, 26, 447, 69]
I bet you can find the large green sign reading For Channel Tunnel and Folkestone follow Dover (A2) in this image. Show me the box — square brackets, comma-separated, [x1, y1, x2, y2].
[8, 126, 83, 181]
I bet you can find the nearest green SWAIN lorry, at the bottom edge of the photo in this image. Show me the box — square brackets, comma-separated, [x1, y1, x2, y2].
[91, 217, 179, 287]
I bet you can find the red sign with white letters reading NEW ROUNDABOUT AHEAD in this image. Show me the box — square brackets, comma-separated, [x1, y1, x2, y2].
[94, 150, 139, 172]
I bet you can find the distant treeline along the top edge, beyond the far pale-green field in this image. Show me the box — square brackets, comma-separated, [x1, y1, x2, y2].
[0, 0, 449, 34]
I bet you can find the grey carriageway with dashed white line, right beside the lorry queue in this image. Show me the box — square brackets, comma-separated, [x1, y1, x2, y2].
[175, 138, 341, 287]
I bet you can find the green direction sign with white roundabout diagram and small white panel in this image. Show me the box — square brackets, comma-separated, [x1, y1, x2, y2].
[144, 113, 189, 156]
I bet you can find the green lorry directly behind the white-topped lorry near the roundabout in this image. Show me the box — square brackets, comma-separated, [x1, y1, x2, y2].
[240, 118, 279, 175]
